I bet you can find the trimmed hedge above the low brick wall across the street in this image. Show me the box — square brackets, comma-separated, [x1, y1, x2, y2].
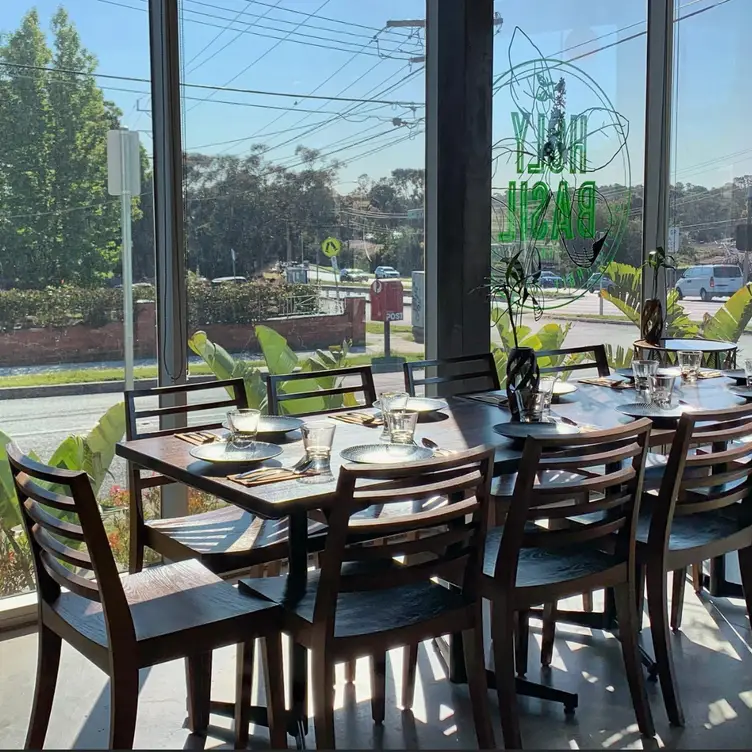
[0, 280, 318, 332]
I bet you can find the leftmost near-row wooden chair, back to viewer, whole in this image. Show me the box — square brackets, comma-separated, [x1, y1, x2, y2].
[241, 448, 494, 749]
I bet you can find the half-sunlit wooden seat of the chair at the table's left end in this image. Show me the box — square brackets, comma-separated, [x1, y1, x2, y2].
[45, 559, 276, 667]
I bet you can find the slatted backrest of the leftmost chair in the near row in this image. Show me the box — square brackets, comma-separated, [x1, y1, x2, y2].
[314, 447, 494, 634]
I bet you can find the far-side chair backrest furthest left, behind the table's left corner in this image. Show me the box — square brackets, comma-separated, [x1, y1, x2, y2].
[125, 379, 248, 441]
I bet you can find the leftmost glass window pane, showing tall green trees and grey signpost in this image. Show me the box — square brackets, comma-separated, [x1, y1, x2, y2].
[0, 0, 156, 596]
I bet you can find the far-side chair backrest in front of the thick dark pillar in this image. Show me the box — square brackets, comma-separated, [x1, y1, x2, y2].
[402, 353, 501, 397]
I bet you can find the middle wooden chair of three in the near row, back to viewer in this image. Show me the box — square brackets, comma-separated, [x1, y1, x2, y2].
[481, 420, 654, 749]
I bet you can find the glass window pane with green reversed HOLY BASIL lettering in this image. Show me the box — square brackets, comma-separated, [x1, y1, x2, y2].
[491, 0, 646, 365]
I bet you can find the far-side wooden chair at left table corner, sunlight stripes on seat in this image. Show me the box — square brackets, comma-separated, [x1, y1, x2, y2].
[125, 379, 288, 576]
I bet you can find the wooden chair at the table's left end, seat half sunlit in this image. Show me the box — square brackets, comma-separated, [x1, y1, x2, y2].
[8, 445, 286, 749]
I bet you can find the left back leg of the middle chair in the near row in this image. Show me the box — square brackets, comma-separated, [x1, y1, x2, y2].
[491, 598, 522, 749]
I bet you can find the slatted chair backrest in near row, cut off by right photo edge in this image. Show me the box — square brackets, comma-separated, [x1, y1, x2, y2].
[649, 404, 752, 545]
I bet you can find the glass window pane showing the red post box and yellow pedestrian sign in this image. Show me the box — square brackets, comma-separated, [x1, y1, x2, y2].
[180, 0, 425, 407]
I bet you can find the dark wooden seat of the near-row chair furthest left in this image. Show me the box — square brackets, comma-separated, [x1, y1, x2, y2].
[241, 560, 467, 645]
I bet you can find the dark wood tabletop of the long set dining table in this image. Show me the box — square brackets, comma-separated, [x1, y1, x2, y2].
[117, 378, 744, 519]
